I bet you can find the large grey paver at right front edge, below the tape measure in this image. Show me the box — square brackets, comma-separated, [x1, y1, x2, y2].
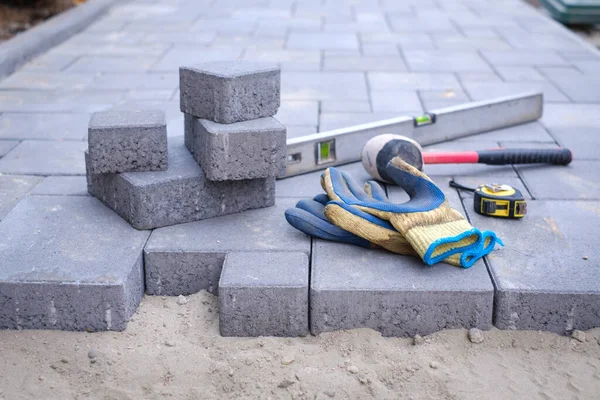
[469, 200, 600, 334]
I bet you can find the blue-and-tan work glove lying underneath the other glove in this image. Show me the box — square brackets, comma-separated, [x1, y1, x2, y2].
[285, 181, 417, 256]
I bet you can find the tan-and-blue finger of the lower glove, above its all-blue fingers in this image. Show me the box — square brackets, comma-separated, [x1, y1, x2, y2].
[325, 201, 416, 255]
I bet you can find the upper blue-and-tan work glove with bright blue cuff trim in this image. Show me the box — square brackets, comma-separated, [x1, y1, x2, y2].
[321, 157, 502, 268]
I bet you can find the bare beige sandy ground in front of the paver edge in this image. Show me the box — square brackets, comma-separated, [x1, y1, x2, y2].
[0, 292, 600, 400]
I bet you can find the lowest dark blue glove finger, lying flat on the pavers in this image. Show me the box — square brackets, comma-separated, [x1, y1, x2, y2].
[285, 208, 372, 248]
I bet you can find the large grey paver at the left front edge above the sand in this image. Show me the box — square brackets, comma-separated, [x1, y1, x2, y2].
[0, 196, 150, 331]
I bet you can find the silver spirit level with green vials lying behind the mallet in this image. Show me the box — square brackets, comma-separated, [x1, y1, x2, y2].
[286, 92, 543, 177]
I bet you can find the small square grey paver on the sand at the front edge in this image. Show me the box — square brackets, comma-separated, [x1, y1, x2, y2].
[219, 252, 308, 337]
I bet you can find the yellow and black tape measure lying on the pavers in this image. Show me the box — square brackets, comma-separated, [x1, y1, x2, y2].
[450, 180, 527, 218]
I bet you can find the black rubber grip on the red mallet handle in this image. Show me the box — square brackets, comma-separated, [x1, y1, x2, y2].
[477, 149, 573, 165]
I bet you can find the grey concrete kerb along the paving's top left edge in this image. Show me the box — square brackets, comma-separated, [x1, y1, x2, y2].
[0, 0, 124, 79]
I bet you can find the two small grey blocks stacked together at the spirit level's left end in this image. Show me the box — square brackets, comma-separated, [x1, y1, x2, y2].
[180, 61, 286, 181]
